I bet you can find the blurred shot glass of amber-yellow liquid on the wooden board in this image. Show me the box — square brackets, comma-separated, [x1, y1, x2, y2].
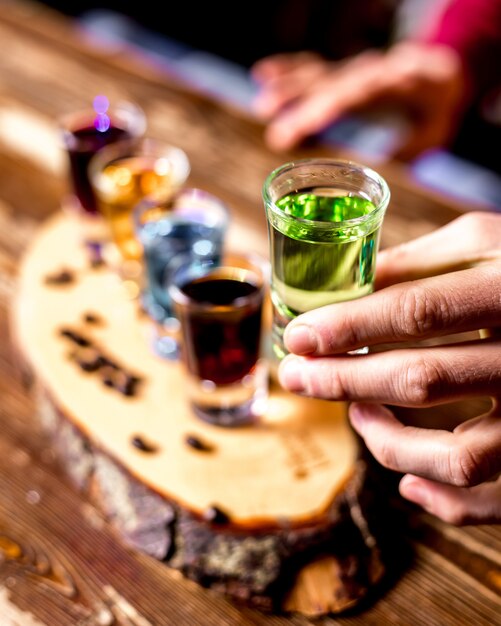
[89, 137, 191, 282]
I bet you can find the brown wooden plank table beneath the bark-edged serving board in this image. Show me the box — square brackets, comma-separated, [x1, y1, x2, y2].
[0, 0, 501, 626]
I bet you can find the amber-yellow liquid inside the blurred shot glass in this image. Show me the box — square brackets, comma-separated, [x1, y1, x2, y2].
[97, 156, 178, 261]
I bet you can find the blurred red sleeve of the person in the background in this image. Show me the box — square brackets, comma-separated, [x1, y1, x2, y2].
[420, 0, 501, 97]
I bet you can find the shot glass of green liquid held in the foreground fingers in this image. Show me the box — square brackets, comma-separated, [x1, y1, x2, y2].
[262, 158, 390, 363]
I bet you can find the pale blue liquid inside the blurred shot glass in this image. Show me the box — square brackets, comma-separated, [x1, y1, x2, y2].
[141, 216, 224, 322]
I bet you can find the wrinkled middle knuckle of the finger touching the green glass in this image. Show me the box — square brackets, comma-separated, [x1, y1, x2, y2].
[393, 286, 449, 339]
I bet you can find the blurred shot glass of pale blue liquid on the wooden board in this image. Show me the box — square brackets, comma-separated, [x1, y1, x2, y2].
[133, 187, 230, 359]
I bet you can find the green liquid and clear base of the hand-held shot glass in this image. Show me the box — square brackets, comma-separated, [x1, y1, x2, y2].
[269, 188, 380, 358]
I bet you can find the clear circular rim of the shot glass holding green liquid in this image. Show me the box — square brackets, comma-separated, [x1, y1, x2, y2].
[262, 157, 391, 229]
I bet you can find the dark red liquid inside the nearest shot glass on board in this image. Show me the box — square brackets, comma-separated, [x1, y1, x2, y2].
[182, 278, 263, 385]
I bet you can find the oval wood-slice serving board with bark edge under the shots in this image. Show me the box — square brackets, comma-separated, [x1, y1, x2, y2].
[12, 212, 385, 615]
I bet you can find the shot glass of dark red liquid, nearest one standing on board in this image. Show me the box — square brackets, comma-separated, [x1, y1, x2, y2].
[169, 253, 268, 427]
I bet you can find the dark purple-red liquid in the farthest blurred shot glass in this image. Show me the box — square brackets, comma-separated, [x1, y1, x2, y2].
[67, 121, 132, 213]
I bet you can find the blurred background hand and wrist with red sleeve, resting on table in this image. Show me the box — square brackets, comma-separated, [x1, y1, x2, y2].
[251, 0, 501, 171]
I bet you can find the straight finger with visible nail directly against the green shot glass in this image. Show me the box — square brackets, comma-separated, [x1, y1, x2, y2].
[284, 262, 501, 356]
